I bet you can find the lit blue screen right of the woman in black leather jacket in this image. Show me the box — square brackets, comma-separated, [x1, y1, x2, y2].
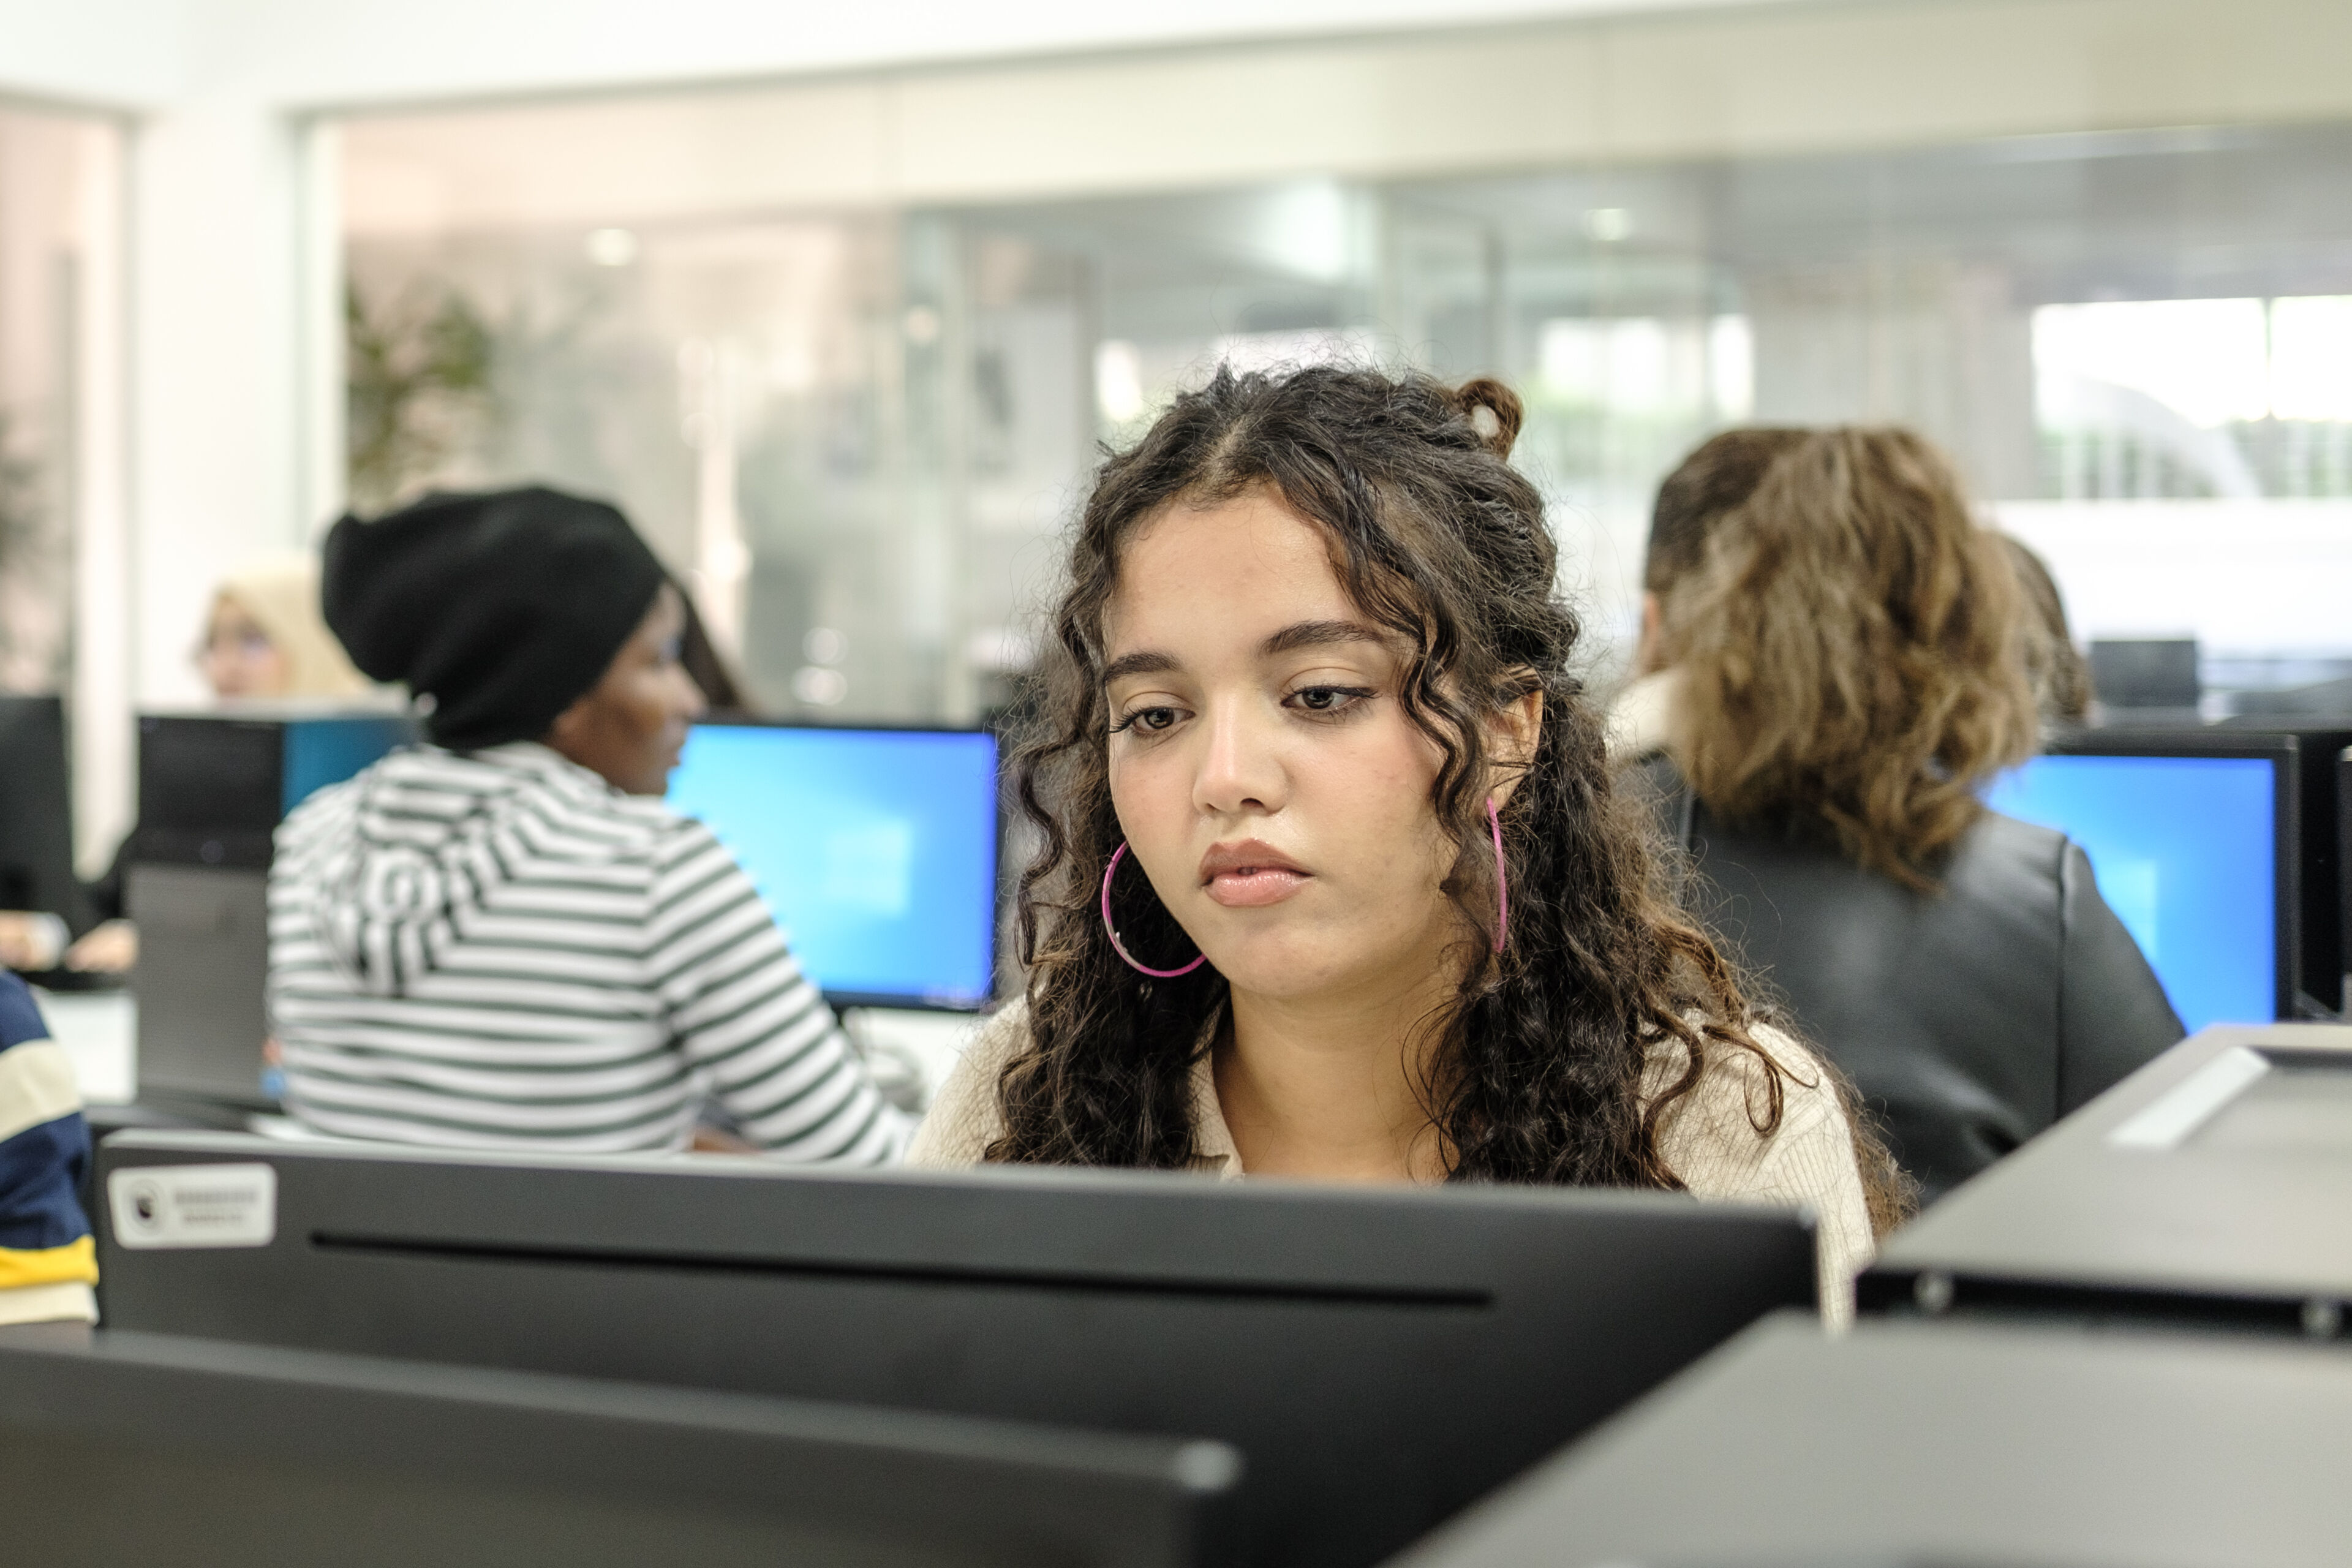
[1985, 757, 2279, 1030]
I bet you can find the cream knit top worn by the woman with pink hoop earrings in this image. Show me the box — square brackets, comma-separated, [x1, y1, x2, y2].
[905, 1001, 1870, 1324]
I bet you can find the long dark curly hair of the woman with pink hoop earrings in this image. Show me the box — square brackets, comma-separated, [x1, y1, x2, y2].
[988, 367, 1868, 1189]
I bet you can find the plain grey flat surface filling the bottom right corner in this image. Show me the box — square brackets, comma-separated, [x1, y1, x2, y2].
[1392, 1316, 2352, 1568]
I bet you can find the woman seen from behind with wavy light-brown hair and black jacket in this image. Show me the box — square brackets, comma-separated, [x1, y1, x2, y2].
[1616, 428, 2180, 1197]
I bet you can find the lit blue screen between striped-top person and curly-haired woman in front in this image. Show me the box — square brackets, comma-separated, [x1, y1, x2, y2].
[670, 724, 997, 1006]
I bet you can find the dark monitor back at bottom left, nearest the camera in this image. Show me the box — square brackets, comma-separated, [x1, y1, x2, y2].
[0, 1330, 1237, 1568]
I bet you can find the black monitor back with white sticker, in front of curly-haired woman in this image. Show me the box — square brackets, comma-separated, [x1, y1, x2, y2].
[99, 1131, 1815, 1568]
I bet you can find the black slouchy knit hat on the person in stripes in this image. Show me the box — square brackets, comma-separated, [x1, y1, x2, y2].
[320, 489, 666, 750]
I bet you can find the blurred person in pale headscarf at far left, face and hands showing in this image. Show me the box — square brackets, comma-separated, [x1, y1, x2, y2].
[0, 555, 374, 973]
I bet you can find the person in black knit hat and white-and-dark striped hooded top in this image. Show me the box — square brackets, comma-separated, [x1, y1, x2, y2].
[271, 489, 910, 1164]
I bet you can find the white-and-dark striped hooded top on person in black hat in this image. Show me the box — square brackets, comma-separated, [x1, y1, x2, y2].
[271, 743, 908, 1164]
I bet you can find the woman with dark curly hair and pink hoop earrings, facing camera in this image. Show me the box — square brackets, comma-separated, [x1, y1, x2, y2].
[908, 369, 1893, 1310]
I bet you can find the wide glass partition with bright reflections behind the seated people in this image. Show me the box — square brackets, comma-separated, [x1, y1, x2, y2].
[344, 104, 2352, 719]
